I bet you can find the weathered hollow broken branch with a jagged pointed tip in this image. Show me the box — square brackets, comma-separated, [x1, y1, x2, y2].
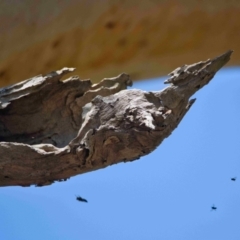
[0, 51, 232, 186]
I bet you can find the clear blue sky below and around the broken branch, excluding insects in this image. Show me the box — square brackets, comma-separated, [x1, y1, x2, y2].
[0, 67, 240, 240]
